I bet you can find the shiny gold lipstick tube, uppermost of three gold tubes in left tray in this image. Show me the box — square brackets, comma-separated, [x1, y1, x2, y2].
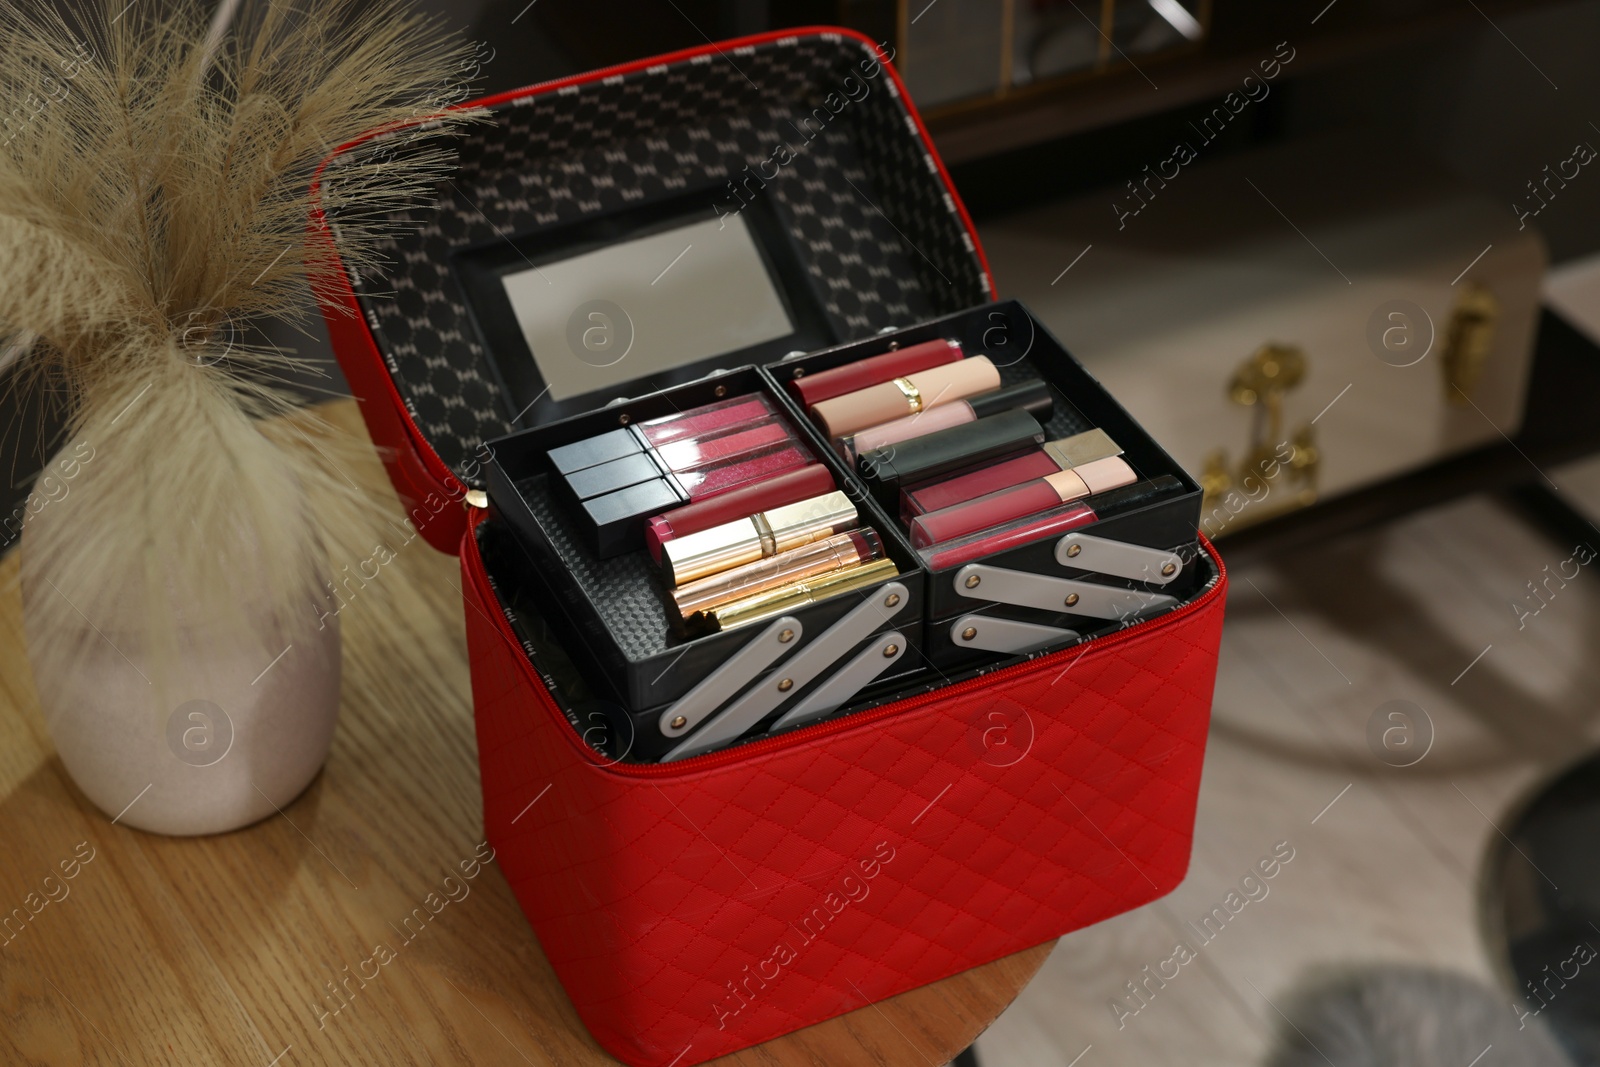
[661, 491, 856, 587]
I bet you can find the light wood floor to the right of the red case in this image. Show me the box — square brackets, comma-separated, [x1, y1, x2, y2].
[978, 461, 1600, 1067]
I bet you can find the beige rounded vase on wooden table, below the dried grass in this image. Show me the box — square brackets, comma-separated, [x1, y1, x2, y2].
[19, 504, 341, 835]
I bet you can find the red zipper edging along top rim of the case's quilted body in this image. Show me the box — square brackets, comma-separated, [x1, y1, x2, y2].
[489, 530, 1227, 779]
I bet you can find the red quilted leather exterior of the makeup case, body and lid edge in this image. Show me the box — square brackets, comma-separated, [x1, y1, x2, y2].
[314, 20, 1226, 1067]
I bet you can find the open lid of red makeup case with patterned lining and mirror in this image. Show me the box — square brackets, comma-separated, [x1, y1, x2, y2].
[312, 29, 994, 552]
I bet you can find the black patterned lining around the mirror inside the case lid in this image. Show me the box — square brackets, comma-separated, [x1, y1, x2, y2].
[328, 34, 990, 488]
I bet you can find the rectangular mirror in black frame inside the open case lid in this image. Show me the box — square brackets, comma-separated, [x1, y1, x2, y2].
[453, 187, 837, 426]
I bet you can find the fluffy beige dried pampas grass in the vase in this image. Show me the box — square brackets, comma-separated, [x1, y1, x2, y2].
[0, 0, 474, 700]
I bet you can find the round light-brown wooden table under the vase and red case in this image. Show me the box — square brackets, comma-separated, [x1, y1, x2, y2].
[0, 402, 1051, 1067]
